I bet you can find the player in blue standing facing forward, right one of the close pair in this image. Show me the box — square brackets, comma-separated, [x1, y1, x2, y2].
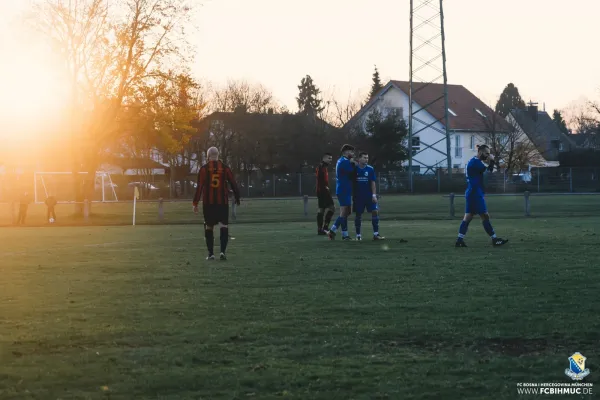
[353, 151, 385, 240]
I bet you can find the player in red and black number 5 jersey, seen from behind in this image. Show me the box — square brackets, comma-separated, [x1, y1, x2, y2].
[193, 147, 240, 260]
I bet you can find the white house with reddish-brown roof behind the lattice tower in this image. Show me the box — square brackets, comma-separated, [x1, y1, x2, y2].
[346, 81, 510, 174]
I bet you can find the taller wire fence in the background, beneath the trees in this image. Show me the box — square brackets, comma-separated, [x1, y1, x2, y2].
[0, 167, 600, 202]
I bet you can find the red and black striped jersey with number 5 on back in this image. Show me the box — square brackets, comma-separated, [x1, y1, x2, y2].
[194, 161, 240, 206]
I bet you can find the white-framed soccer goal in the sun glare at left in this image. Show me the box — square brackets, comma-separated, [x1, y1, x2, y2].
[33, 172, 118, 203]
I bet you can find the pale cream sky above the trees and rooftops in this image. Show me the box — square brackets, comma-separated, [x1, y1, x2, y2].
[0, 0, 600, 115]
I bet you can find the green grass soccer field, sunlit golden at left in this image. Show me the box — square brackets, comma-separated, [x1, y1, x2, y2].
[0, 203, 600, 400]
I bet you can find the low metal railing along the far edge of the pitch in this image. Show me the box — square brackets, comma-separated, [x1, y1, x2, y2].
[0, 192, 600, 227]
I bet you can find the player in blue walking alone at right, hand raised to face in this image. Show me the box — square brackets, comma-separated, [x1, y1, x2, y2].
[456, 145, 508, 247]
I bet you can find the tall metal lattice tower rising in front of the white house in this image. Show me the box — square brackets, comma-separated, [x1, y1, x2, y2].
[408, 0, 452, 192]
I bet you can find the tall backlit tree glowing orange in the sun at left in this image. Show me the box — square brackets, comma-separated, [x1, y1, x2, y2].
[32, 0, 192, 212]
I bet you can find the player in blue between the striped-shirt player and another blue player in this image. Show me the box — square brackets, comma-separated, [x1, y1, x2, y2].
[327, 144, 356, 240]
